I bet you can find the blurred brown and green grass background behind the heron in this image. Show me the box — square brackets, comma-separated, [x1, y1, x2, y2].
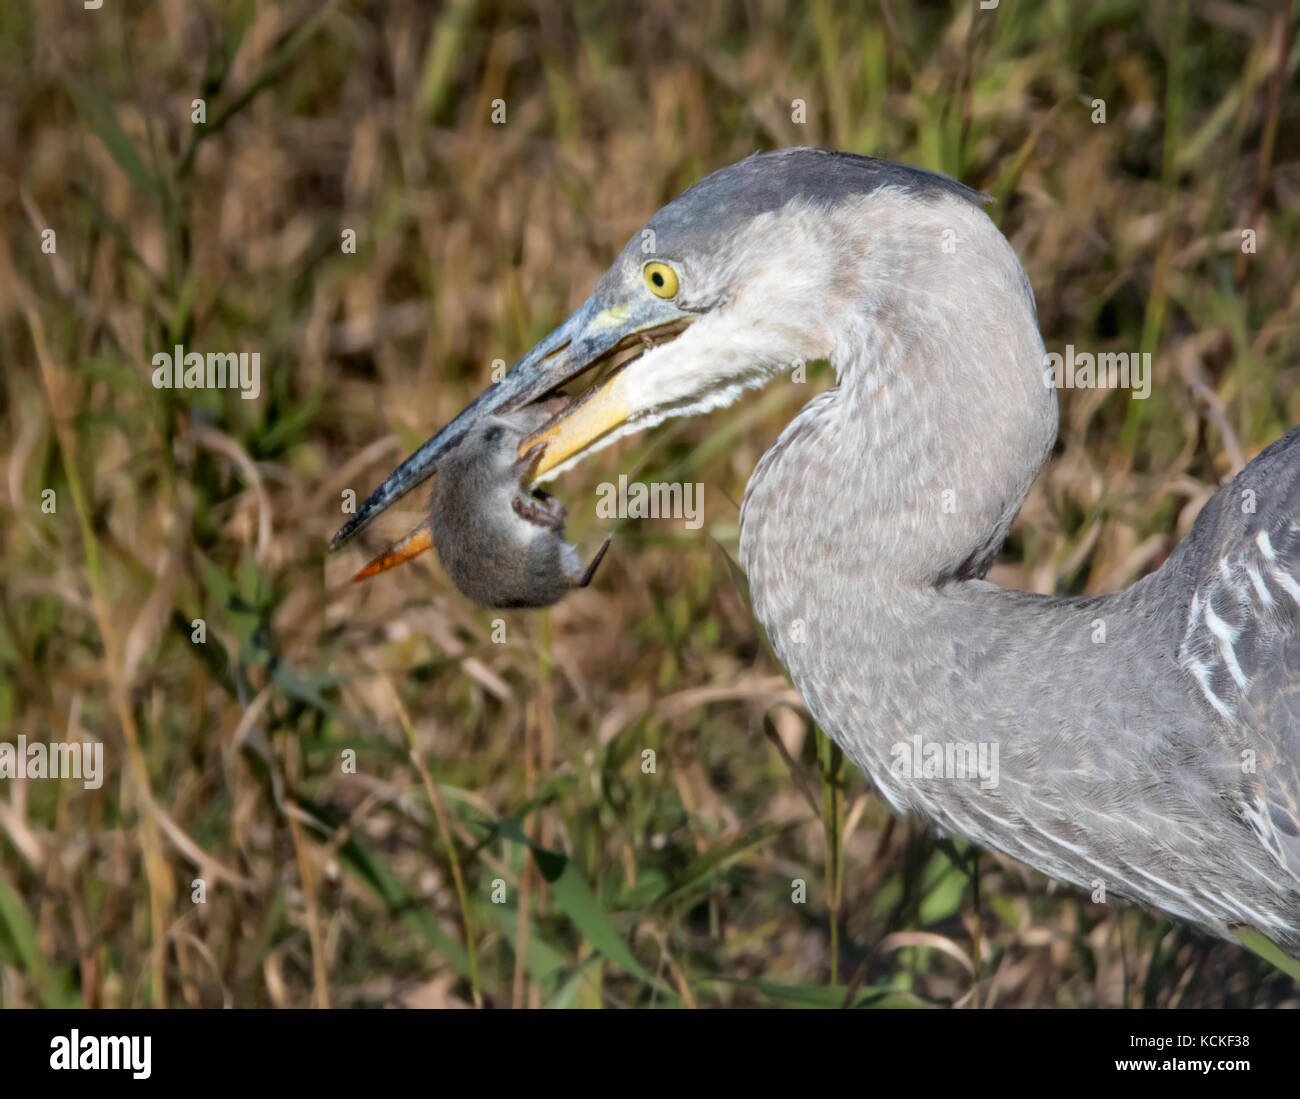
[0, 0, 1300, 1007]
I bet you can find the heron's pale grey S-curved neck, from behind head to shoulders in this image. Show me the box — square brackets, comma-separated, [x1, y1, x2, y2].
[741, 204, 1057, 600]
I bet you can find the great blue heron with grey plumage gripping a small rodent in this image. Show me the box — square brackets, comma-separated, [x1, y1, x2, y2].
[332, 148, 1300, 955]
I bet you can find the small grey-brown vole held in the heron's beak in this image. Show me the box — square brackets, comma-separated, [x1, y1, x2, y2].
[429, 406, 610, 607]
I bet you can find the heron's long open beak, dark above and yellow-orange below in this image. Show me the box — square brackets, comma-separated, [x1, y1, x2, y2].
[330, 290, 694, 567]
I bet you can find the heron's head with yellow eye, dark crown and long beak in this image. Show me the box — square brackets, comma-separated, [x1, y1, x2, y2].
[330, 150, 979, 561]
